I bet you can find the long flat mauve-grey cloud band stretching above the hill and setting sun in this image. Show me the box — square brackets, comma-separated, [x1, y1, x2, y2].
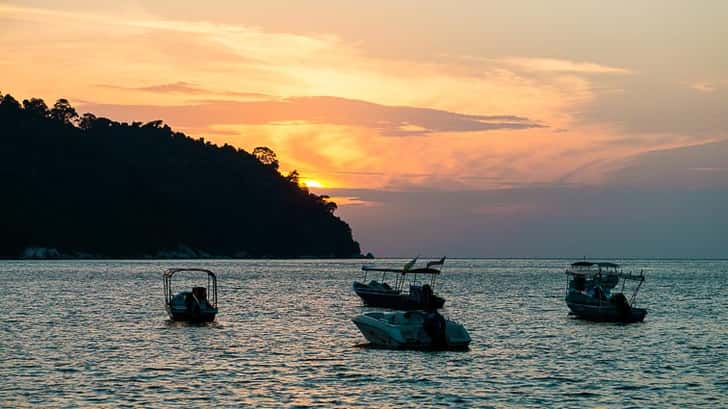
[82, 95, 544, 136]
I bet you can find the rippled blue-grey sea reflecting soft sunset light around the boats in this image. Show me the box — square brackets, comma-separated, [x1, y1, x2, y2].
[0, 260, 728, 408]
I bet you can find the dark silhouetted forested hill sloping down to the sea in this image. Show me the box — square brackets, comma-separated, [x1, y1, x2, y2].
[0, 95, 360, 258]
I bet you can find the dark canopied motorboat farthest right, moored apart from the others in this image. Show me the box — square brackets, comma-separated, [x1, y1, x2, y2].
[565, 261, 647, 323]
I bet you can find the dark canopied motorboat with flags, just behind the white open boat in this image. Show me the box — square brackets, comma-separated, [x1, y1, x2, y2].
[353, 257, 445, 310]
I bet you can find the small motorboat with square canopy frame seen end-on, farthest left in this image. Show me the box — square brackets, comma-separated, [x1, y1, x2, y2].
[162, 268, 217, 322]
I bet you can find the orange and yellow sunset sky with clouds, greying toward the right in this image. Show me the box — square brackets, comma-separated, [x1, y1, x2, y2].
[0, 0, 728, 258]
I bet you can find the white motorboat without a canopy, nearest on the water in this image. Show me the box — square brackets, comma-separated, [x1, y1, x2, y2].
[352, 311, 470, 350]
